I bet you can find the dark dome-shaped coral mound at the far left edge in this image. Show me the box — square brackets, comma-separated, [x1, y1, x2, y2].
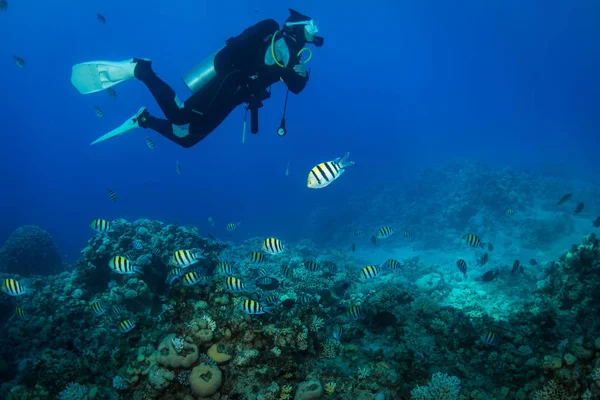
[0, 225, 63, 276]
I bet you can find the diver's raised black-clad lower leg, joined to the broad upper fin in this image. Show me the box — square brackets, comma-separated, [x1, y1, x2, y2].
[134, 59, 190, 125]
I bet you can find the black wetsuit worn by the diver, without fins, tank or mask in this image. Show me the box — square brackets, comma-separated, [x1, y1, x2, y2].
[136, 19, 308, 147]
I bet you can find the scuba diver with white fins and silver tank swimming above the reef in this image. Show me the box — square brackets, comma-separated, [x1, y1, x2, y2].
[71, 9, 324, 148]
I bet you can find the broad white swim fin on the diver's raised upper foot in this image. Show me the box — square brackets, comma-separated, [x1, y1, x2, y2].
[71, 58, 137, 94]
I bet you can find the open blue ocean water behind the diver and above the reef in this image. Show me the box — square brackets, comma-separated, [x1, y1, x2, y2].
[0, 0, 600, 260]
